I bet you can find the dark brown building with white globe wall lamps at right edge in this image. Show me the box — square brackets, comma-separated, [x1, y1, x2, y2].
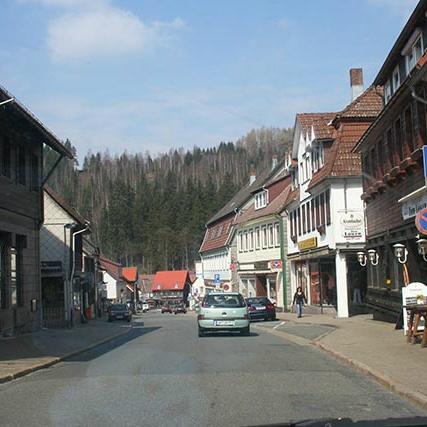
[356, 1, 427, 321]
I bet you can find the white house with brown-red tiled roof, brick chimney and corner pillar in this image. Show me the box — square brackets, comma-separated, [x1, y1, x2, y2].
[286, 69, 382, 317]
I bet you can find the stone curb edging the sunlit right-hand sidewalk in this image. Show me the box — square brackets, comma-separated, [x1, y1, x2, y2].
[312, 341, 427, 409]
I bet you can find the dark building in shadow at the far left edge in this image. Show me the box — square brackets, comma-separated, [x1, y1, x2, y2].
[0, 87, 72, 335]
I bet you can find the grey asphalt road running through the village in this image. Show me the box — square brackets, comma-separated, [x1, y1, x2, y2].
[0, 313, 426, 427]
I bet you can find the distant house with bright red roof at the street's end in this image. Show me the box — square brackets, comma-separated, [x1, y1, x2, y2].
[151, 270, 191, 305]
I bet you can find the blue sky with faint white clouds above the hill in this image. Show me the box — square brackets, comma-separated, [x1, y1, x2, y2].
[0, 0, 417, 159]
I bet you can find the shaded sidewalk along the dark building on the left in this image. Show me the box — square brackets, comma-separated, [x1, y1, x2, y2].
[0, 319, 132, 383]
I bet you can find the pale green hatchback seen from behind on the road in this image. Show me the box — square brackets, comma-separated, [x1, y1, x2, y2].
[197, 292, 250, 337]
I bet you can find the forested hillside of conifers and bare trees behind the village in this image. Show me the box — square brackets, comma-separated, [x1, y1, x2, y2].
[45, 128, 291, 273]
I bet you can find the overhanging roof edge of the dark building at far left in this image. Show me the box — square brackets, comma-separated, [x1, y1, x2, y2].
[0, 85, 74, 159]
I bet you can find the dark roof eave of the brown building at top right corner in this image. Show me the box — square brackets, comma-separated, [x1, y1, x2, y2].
[373, 0, 427, 86]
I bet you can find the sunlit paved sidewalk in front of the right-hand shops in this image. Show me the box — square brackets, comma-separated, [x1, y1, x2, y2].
[273, 313, 427, 409]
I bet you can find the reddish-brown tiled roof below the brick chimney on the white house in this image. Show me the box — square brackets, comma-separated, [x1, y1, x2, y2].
[308, 86, 383, 190]
